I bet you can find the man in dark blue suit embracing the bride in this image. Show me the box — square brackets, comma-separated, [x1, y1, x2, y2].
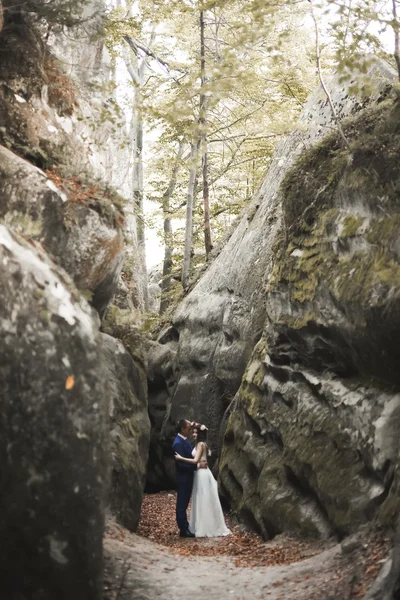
[172, 419, 196, 537]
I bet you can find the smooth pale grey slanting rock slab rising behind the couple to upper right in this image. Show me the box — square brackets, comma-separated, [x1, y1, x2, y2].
[145, 64, 394, 496]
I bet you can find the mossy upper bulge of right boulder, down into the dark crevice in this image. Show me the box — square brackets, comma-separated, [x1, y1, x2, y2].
[267, 100, 400, 384]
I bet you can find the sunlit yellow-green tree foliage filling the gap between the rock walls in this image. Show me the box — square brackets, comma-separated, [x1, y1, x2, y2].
[111, 0, 316, 284]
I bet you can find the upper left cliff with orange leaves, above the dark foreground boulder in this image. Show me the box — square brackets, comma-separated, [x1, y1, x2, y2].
[0, 14, 129, 315]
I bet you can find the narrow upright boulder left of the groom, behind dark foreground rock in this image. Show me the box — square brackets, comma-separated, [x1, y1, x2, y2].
[102, 334, 150, 531]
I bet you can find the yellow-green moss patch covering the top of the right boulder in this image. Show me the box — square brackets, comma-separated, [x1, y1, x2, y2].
[268, 101, 400, 303]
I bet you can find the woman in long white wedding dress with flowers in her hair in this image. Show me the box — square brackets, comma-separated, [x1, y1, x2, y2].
[175, 425, 231, 537]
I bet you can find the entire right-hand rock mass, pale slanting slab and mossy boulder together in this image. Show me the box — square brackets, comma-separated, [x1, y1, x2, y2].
[149, 65, 400, 537]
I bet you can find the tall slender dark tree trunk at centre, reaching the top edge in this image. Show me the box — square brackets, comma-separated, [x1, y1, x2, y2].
[199, 10, 212, 260]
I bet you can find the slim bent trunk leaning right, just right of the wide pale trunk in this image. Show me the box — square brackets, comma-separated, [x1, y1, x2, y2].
[160, 142, 184, 315]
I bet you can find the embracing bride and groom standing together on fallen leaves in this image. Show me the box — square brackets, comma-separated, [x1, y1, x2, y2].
[172, 419, 230, 538]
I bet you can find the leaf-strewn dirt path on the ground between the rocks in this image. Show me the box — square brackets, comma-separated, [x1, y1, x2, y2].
[104, 492, 388, 600]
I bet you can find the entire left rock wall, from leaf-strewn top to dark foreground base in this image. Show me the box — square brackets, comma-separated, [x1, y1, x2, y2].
[0, 0, 149, 600]
